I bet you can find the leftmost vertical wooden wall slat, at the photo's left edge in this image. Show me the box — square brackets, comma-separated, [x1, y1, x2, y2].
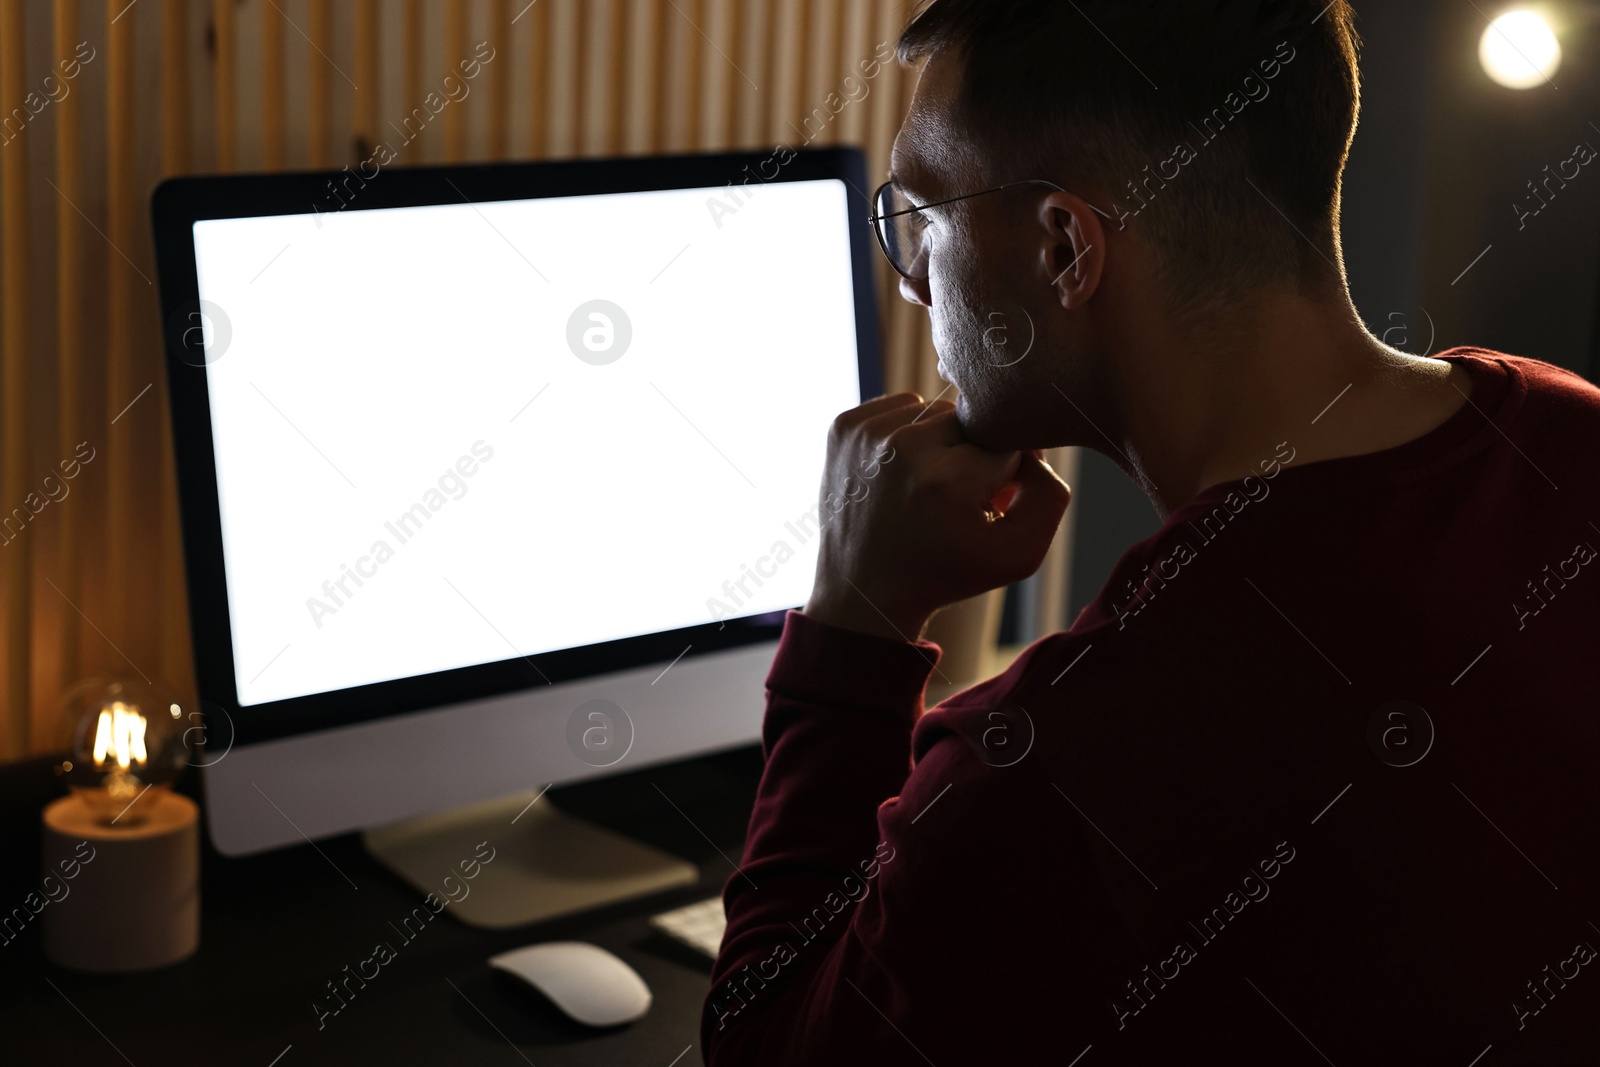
[0, 0, 34, 758]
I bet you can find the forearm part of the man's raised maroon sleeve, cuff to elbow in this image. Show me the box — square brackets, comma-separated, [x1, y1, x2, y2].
[701, 611, 941, 1064]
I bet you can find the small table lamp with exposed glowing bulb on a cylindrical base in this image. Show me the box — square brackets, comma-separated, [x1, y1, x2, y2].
[40, 678, 200, 973]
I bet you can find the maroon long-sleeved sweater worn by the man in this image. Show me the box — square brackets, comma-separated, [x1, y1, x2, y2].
[702, 349, 1600, 1067]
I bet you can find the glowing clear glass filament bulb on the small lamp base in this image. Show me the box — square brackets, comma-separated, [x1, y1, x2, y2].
[56, 678, 189, 827]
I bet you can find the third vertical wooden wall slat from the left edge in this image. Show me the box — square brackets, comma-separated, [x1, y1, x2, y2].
[101, 0, 142, 668]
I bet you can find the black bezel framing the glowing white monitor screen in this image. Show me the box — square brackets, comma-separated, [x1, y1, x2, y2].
[150, 147, 882, 747]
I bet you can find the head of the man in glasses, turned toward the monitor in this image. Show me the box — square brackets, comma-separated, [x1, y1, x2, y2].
[893, 0, 1358, 448]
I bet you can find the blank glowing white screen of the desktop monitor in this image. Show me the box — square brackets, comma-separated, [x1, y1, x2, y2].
[194, 181, 861, 705]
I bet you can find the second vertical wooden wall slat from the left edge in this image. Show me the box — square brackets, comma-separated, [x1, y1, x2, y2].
[54, 0, 86, 726]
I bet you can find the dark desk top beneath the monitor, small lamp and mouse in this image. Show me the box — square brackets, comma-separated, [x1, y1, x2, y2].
[0, 749, 760, 1067]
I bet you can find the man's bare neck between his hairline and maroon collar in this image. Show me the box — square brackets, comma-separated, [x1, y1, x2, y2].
[1110, 283, 1472, 518]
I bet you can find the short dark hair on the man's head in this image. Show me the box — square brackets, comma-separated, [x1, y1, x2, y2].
[898, 0, 1360, 314]
